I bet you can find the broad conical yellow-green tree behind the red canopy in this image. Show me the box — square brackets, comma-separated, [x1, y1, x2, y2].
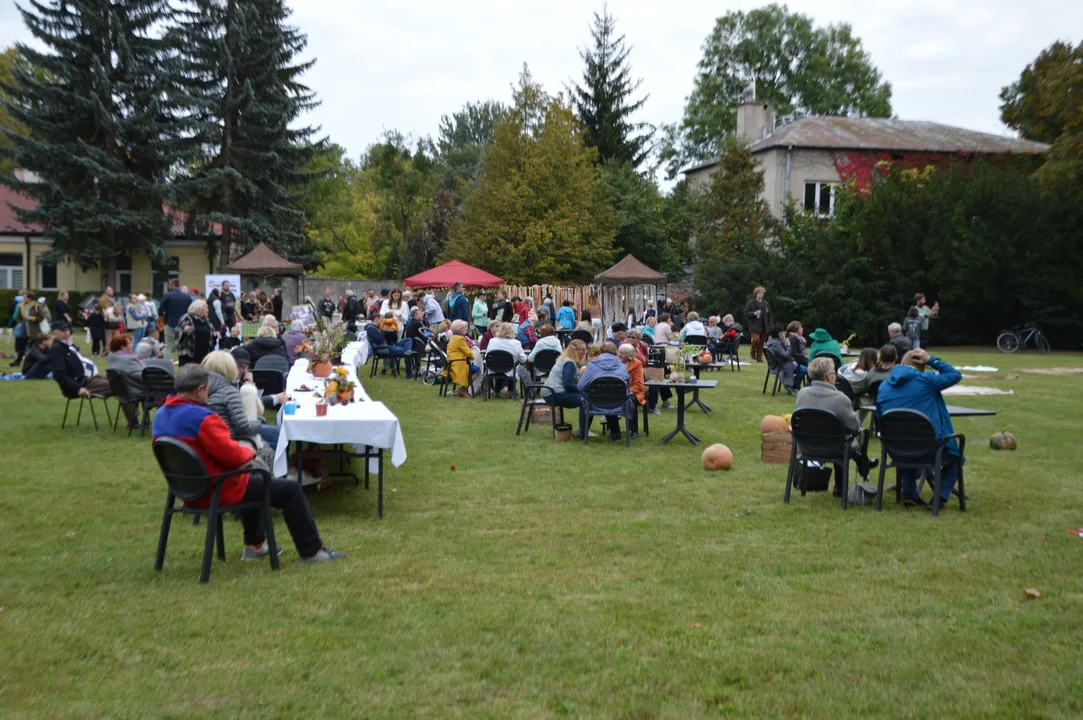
[444, 69, 616, 284]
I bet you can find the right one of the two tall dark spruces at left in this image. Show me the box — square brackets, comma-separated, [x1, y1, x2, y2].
[173, 0, 325, 266]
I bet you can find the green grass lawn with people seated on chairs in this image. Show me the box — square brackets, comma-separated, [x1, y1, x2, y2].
[0, 339, 1083, 719]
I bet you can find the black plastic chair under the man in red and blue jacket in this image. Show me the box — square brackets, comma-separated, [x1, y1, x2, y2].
[153, 437, 278, 582]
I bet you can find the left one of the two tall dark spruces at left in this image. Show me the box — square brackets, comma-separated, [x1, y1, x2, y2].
[3, 0, 179, 283]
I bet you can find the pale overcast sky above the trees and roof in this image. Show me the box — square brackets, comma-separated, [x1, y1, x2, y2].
[0, 0, 1083, 169]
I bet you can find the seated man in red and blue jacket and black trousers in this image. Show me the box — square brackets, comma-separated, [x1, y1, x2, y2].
[152, 365, 345, 563]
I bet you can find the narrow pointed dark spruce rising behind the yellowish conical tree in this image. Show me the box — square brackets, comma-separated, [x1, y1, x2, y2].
[569, 8, 651, 169]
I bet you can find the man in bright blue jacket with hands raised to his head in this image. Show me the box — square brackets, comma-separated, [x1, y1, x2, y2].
[876, 349, 963, 508]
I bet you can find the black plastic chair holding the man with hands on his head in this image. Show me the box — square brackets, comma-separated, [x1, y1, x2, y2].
[876, 409, 966, 518]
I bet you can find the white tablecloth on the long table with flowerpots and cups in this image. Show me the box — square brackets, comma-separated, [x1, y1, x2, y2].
[274, 358, 406, 477]
